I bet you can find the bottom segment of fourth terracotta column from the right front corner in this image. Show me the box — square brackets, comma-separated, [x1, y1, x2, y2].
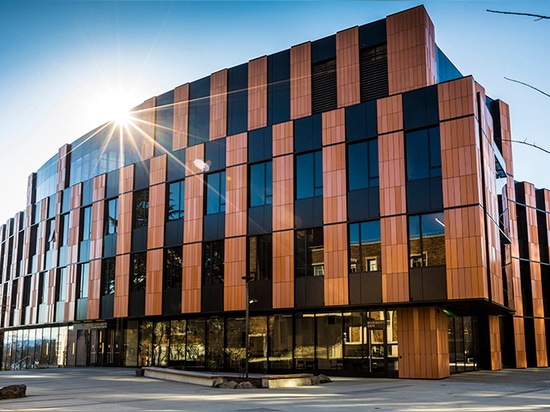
[272, 230, 294, 309]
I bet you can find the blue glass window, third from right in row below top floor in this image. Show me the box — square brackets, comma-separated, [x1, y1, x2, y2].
[296, 150, 323, 199]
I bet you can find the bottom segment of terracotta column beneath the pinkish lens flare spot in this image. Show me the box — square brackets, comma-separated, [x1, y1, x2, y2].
[181, 243, 202, 313]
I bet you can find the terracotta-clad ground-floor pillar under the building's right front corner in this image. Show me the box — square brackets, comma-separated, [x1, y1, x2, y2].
[398, 307, 450, 379]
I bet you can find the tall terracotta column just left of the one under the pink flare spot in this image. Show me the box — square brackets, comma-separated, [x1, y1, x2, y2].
[145, 155, 168, 316]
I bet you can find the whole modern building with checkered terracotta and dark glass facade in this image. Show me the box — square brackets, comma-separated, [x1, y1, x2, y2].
[0, 6, 550, 378]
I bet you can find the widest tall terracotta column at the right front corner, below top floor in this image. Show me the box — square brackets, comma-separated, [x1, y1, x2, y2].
[438, 77, 488, 299]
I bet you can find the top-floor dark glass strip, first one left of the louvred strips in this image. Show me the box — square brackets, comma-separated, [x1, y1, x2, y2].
[267, 50, 290, 125]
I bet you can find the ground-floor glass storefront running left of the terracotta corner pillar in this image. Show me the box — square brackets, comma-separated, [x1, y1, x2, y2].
[2, 311, 398, 377]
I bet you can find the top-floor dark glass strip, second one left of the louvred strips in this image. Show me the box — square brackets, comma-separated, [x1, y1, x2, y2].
[227, 63, 248, 135]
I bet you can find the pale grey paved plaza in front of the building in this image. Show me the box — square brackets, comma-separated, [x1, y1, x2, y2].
[0, 368, 550, 412]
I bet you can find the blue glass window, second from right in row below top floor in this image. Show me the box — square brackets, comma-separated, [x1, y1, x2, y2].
[348, 139, 379, 191]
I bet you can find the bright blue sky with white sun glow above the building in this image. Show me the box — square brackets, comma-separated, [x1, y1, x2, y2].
[0, 0, 550, 222]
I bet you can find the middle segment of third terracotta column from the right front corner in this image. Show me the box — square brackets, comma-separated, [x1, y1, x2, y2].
[323, 144, 347, 224]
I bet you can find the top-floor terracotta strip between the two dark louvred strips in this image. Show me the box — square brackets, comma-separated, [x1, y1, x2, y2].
[336, 27, 361, 107]
